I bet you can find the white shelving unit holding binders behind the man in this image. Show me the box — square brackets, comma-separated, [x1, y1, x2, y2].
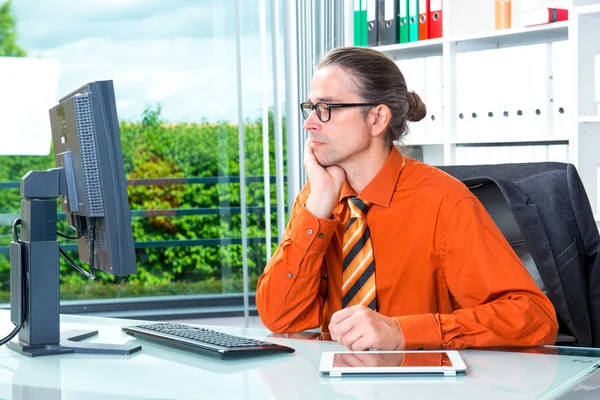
[347, 0, 600, 221]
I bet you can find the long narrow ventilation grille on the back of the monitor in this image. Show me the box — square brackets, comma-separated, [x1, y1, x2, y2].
[73, 95, 104, 217]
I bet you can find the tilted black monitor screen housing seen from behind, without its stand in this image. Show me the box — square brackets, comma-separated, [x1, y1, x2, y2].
[50, 81, 137, 276]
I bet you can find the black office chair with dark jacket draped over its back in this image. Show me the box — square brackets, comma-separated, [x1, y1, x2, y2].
[439, 163, 600, 347]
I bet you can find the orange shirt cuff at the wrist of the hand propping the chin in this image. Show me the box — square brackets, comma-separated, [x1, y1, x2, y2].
[290, 206, 339, 251]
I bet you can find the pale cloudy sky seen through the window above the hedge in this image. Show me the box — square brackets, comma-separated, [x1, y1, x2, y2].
[13, 0, 285, 123]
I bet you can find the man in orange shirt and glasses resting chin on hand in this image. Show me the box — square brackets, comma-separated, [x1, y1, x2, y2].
[256, 47, 558, 350]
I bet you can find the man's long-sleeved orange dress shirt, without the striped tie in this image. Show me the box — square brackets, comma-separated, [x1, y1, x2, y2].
[256, 148, 558, 349]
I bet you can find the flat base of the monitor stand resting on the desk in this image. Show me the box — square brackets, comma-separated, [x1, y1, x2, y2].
[7, 330, 142, 357]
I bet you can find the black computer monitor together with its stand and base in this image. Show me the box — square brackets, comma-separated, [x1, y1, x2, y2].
[9, 81, 141, 356]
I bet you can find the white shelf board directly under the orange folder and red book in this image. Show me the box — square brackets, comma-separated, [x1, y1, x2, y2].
[450, 21, 569, 53]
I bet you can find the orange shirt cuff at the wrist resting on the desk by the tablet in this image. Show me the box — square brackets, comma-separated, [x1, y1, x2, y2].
[394, 314, 442, 350]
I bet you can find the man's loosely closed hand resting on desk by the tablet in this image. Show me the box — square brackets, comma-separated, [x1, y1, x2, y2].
[329, 306, 404, 351]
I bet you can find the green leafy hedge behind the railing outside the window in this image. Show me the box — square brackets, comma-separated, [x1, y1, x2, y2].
[0, 106, 285, 298]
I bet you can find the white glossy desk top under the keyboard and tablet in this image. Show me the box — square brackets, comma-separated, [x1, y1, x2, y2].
[0, 311, 600, 400]
